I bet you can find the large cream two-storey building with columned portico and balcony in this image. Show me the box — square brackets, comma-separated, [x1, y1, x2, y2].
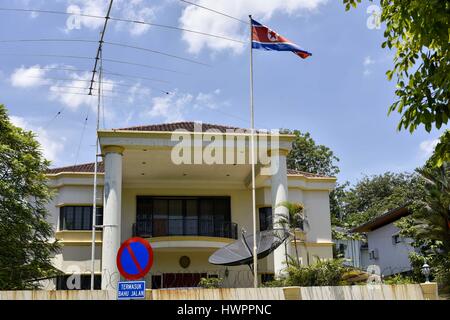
[44, 122, 336, 289]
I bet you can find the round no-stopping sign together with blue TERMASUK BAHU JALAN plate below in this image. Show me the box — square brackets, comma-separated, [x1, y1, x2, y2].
[116, 237, 153, 300]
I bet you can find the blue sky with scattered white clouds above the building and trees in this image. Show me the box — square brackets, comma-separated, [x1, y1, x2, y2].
[0, 0, 440, 183]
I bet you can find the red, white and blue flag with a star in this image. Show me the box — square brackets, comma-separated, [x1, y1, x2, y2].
[251, 19, 312, 59]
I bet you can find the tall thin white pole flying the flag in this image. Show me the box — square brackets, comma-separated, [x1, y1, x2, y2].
[249, 15, 258, 288]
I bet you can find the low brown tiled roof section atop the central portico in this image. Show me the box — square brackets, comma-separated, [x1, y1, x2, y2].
[115, 121, 246, 133]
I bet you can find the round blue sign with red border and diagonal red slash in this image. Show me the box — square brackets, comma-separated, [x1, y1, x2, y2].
[116, 237, 153, 280]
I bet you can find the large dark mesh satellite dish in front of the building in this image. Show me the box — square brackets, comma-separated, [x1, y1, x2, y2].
[208, 229, 289, 266]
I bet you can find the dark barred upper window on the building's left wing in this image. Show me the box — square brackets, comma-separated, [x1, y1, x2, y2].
[59, 206, 103, 230]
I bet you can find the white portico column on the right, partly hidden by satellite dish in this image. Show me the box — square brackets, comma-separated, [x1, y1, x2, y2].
[270, 150, 290, 277]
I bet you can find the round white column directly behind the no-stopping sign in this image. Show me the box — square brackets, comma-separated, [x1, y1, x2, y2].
[102, 146, 123, 290]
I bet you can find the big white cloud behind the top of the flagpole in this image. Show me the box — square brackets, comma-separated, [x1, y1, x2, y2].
[179, 0, 328, 54]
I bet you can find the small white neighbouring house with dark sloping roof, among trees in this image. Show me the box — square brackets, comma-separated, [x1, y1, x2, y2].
[353, 207, 415, 276]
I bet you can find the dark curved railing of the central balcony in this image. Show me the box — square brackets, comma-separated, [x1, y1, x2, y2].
[133, 218, 237, 239]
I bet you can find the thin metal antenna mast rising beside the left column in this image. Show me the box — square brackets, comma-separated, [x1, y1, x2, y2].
[91, 49, 103, 290]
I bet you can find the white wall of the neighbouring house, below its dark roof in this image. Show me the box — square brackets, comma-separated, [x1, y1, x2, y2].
[367, 223, 414, 276]
